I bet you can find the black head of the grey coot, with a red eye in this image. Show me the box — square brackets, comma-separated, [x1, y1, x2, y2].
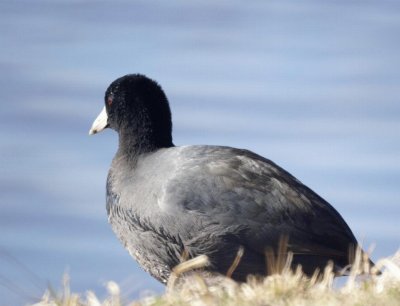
[91, 74, 173, 151]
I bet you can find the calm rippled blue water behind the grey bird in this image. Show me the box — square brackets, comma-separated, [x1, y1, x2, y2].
[0, 0, 400, 305]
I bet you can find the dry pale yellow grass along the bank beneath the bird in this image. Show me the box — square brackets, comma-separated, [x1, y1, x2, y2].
[32, 251, 400, 306]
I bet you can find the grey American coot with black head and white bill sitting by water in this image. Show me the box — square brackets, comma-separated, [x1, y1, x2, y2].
[89, 74, 372, 283]
